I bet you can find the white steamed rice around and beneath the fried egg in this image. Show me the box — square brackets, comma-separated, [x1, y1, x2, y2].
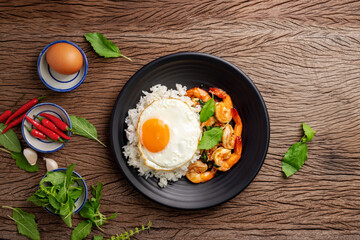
[124, 84, 200, 187]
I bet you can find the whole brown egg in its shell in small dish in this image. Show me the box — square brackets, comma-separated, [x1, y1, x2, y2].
[46, 43, 84, 75]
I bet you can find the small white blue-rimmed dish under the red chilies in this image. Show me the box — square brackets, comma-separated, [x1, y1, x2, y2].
[21, 103, 71, 153]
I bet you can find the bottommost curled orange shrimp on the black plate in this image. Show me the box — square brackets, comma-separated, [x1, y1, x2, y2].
[186, 160, 216, 183]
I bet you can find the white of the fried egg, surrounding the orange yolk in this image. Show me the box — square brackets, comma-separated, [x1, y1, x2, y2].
[137, 98, 201, 171]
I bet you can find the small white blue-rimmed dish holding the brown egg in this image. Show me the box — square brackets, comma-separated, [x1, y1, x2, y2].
[37, 40, 88, 92]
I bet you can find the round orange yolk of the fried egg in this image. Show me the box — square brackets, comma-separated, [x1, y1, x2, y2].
[141, 119, 170, 152]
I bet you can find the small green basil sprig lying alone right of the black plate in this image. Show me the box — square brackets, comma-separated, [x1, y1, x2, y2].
[282, 123, 316, 177]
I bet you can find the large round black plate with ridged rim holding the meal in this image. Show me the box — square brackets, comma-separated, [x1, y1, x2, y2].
[111, 52, 270, 209]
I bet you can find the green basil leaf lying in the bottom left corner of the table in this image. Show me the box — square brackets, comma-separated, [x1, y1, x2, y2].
[3, 206, 40, 240]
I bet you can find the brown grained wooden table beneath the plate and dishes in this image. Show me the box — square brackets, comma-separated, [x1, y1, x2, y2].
[0, 0, 360, 239]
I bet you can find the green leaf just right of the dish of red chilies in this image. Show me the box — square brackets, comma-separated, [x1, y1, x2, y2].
[70, 116, 106, 147]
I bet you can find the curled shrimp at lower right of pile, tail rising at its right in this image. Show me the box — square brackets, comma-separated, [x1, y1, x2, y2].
[213, 137, 242, 172]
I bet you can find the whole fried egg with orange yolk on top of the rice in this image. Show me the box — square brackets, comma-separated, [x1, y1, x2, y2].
[137, 98, 201, 171]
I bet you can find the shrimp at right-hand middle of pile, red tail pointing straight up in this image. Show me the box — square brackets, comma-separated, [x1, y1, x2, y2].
[221, 108, 242, 149]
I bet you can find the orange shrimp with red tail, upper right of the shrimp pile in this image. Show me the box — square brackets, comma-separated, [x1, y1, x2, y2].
[209, 88, 233, 123]
